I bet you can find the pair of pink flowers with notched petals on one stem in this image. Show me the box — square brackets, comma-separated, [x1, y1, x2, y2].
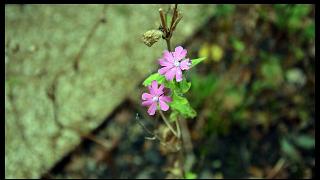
[141, 46, 191, 116]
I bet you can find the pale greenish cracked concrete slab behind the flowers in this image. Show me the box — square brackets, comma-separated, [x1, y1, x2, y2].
[5, 5, 214, 178]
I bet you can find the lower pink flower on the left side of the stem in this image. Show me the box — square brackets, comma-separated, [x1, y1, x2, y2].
[142, 81, 172, 116]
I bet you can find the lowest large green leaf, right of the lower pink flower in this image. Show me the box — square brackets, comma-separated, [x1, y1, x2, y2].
[170, 92, 197, 118]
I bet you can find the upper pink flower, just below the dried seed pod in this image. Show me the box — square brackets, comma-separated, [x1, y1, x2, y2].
[158, 46, 191, 82]
